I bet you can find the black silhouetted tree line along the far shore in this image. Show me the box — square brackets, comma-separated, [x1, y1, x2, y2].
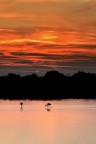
[0, 71, 96, 100]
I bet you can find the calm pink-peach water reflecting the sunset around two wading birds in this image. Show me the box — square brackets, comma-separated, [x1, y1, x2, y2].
[0, 100, 96, 144]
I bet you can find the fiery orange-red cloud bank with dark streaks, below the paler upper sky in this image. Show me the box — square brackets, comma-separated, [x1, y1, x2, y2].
[0, 24, 96, 74]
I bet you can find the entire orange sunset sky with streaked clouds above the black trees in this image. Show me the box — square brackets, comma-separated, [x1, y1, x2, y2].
[0, 0, 96, 75]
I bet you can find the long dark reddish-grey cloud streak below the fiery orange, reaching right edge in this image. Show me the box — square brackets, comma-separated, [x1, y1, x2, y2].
[11, 52, 96, 60]
